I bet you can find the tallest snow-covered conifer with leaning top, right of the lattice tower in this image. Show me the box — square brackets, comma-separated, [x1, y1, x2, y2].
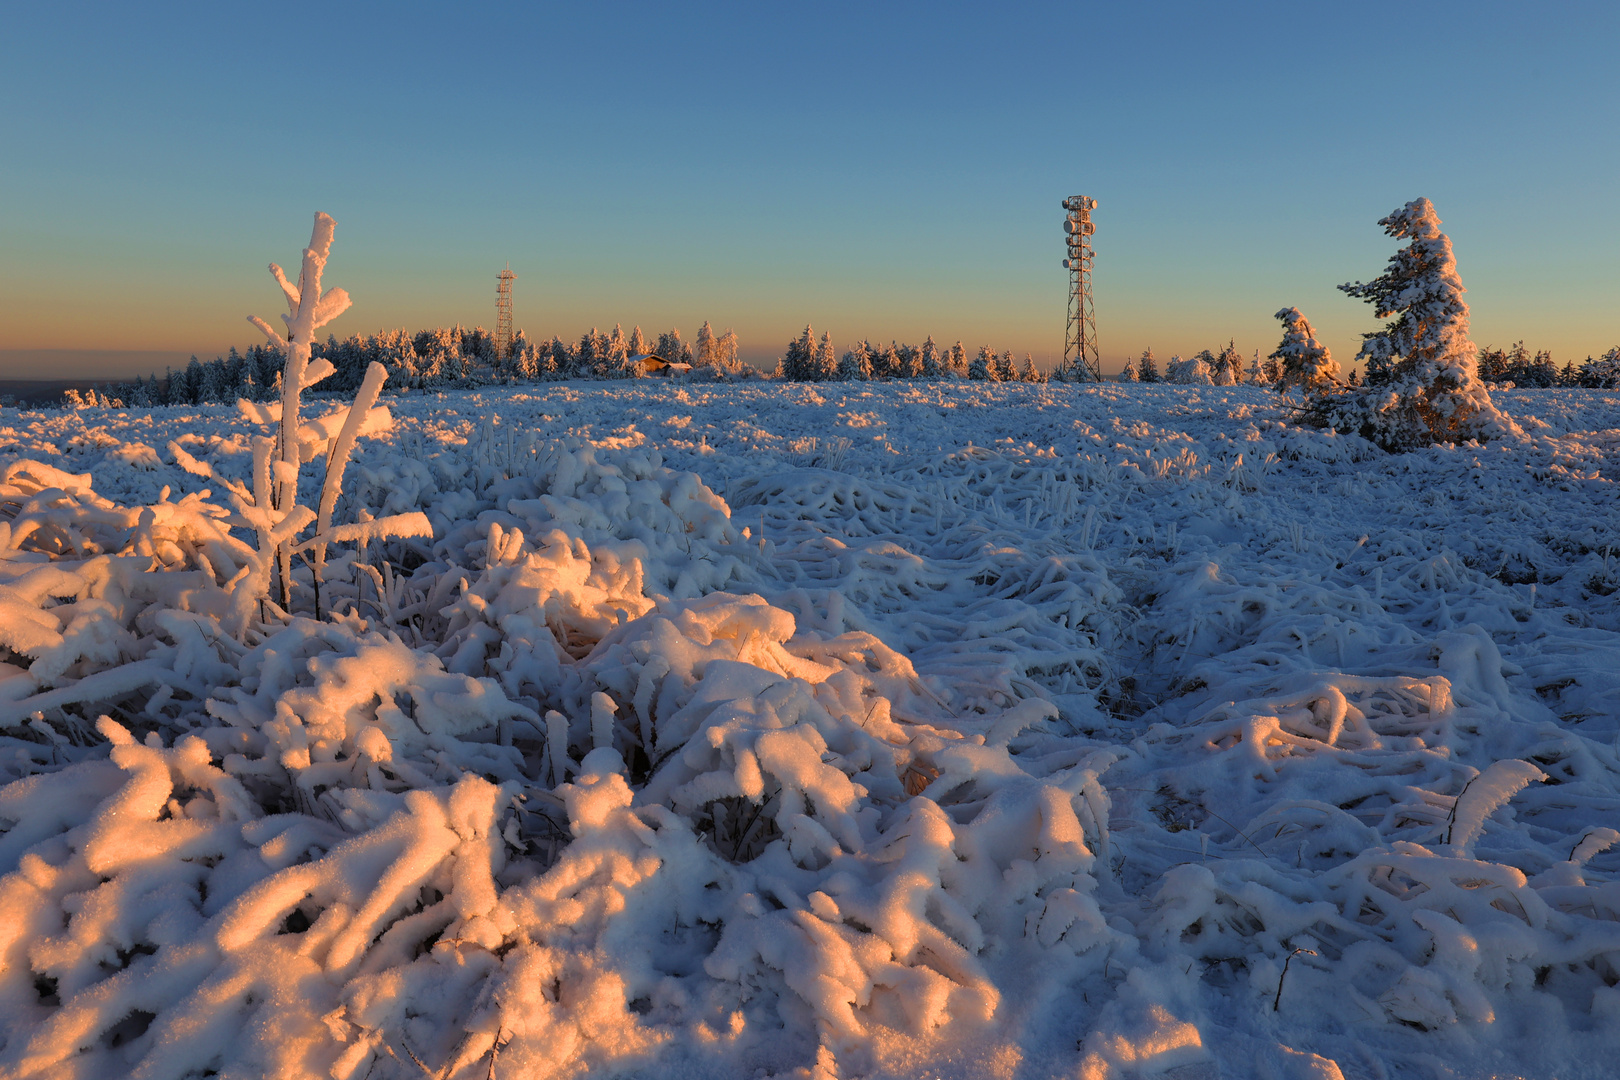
[1307, 199, 1518, 450]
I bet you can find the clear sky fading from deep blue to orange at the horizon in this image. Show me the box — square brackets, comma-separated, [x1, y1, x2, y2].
[0, 0, 1620, 377]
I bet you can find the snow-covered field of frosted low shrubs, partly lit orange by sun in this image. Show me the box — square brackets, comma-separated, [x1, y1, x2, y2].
[0, 381, 1620, 1080]
